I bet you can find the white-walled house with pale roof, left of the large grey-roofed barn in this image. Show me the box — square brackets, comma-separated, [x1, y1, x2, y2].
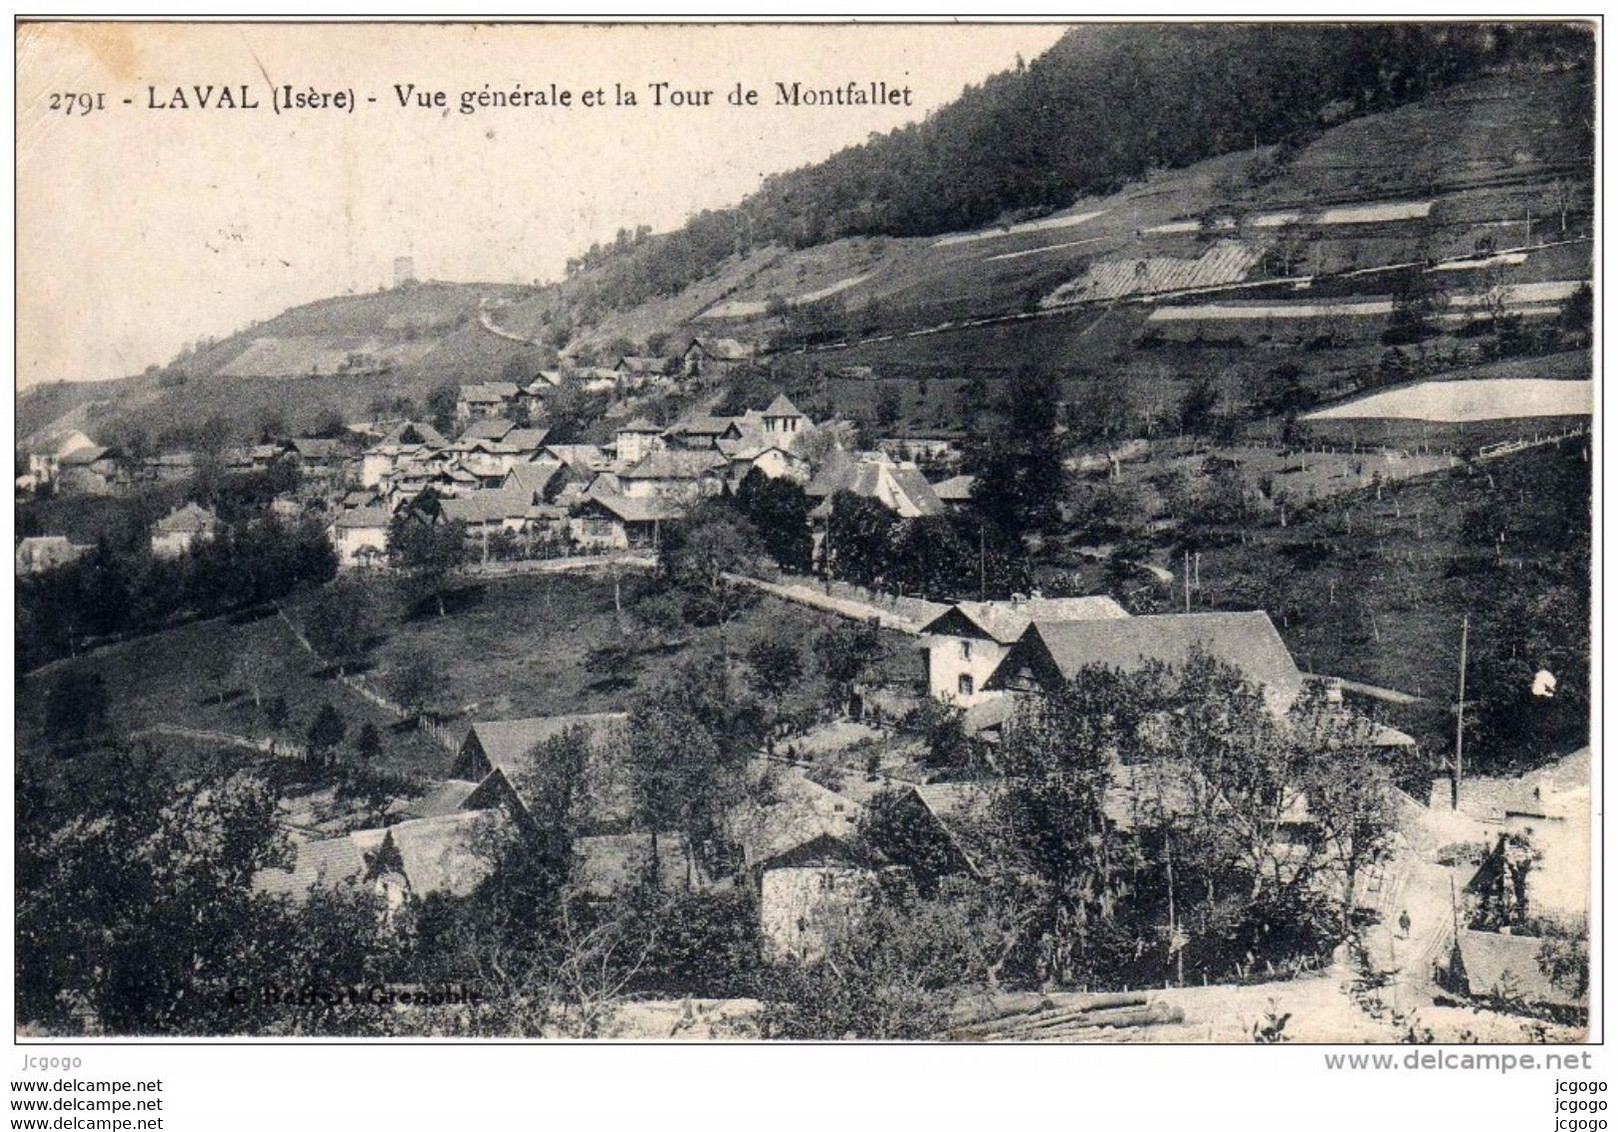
[921, 597, 1129, 707]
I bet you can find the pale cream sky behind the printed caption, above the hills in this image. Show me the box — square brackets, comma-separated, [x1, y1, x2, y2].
[16, 23, 1063, 388]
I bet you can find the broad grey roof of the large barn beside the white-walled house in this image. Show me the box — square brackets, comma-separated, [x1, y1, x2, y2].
[985, 611, 1302, 715]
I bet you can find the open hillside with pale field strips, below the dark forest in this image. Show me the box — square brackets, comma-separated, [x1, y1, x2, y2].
[19, 39, 1594, 452]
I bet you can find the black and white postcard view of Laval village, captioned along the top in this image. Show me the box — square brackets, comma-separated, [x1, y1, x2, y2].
[10, 18, 1602, 1060]
